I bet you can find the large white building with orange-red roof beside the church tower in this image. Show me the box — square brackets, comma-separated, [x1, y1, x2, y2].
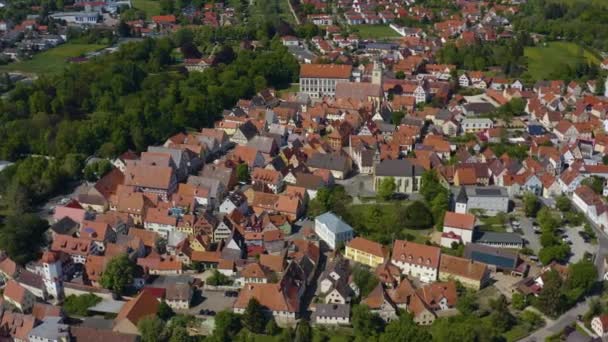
[300, 64, 353, 99]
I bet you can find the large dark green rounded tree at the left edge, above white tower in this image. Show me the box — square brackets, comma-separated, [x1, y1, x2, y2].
[0, 214, 49, 265]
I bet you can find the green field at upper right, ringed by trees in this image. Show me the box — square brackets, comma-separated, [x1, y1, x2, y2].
[524, 42, 600, 80]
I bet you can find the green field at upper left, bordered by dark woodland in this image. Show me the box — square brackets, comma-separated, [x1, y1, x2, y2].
[0, 44, 106, 74]
